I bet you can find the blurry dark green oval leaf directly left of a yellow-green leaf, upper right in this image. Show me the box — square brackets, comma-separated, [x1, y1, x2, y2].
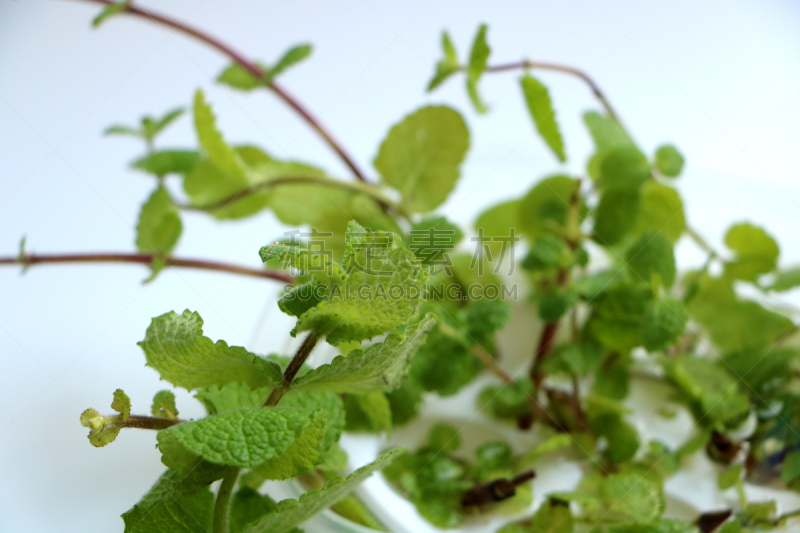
[592, 189, 642, 246]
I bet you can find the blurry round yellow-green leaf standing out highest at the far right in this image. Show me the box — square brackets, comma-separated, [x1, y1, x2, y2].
[725, 223, 778, 281]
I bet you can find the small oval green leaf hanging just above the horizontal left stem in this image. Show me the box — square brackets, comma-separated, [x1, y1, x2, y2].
[136, 186, 183, 254]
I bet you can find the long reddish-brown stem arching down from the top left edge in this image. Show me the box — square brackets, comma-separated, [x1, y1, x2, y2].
[77, 0, 368, 182]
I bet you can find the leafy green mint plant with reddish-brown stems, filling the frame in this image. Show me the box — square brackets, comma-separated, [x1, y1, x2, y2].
[0, 0, 800, 533]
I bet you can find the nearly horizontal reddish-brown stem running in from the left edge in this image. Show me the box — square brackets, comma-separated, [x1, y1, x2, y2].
[0, 253, 294, 283]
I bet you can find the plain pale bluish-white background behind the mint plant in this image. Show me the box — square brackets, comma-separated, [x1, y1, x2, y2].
[0, 0, 800, 533]
